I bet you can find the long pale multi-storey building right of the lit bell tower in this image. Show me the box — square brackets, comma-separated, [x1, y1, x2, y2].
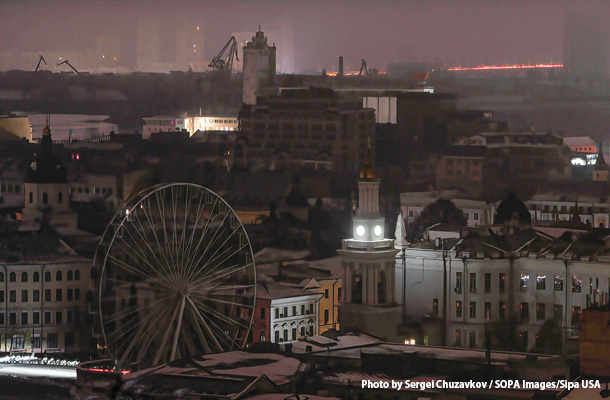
[396, 232, 610, 351]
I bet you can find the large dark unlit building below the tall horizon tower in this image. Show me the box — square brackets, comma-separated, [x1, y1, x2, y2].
[240, 88, 375, 171]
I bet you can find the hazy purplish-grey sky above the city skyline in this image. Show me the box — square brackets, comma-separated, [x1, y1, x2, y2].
[0, 0, 610, 70]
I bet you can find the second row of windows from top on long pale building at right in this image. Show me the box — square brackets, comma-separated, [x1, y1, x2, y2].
[455, 300, 580, 326]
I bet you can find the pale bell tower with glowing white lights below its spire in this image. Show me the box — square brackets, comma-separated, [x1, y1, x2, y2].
[339, 149, 400, 340]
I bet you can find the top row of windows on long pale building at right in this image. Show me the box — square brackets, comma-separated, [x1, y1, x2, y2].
[455, 272, 588, 293]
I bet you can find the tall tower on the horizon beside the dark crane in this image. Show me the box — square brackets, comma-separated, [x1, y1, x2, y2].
[243, 26, 276, 104]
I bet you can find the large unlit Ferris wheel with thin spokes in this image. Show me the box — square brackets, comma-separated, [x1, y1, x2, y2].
[94, 183, 256, 370]
